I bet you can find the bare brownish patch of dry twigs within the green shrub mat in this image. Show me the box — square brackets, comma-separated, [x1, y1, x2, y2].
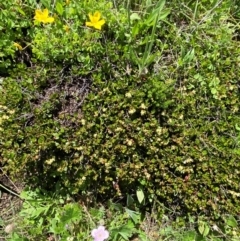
[17, 68, 92, 127]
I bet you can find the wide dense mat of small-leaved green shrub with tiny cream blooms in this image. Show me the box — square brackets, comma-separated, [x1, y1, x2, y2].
[0, 1, 240, 220]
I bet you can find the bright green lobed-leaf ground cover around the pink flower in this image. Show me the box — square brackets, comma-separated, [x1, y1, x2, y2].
[1, 189, 239, 241]
